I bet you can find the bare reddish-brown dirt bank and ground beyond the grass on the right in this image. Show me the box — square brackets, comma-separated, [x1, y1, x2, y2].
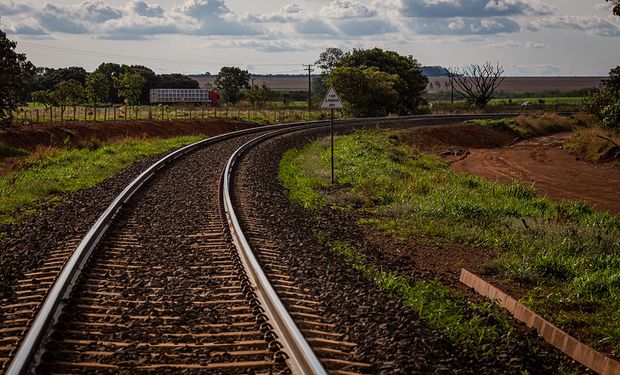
[404, 124, 620, 215]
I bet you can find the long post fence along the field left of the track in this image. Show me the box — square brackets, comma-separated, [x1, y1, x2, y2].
[7, 106, 342, 125]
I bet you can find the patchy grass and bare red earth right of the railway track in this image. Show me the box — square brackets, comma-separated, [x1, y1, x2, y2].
[281, 124, 620, 364]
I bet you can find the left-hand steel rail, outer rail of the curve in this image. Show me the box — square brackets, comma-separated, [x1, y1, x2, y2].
[6, 114, 518, 375]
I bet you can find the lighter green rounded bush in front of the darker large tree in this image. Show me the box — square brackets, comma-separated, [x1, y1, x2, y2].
[327, 67, 400, 117]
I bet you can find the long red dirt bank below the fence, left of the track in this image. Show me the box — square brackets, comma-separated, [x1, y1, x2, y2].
[0, 120, 258, 176]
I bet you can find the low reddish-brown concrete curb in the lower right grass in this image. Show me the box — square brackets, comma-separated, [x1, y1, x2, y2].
[460, 268, 620, 375]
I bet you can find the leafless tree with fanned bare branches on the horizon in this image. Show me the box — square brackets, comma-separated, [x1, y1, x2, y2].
[448, 62, 505, 108]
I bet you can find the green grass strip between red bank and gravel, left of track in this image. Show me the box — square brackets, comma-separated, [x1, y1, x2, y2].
[0, 136, 204, 224]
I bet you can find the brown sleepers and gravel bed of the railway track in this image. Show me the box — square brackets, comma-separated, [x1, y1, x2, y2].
[0, 117, 524, 373]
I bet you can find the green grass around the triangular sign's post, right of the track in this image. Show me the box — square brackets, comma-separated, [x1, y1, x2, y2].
[280, 131, 620, 356]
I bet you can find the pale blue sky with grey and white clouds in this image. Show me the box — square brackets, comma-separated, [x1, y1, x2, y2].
[0, 0, 620, 76]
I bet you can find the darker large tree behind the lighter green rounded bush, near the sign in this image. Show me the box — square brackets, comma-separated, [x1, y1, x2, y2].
[336, 48, 428, 115]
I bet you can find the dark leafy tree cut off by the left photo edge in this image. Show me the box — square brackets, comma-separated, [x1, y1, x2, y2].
[0, 26, 35, 124]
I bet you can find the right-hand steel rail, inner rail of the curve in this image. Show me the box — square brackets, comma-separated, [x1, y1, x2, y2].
[222, 124, 327, 375]
